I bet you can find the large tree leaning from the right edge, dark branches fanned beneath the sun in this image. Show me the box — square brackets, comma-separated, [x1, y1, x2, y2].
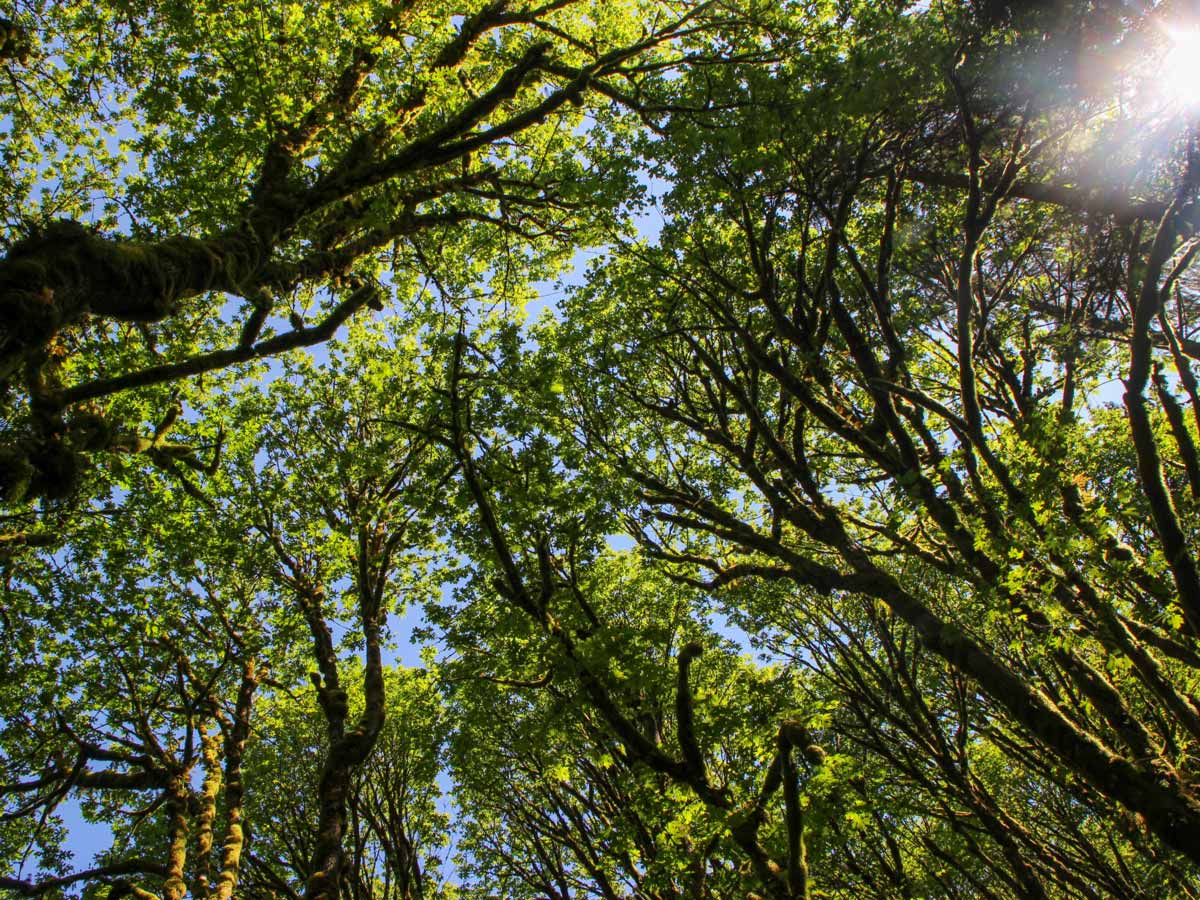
[540, 0, 1200, 893]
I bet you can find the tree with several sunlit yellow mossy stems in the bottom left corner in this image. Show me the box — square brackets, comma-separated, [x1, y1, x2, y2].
[0, 458, 267, 899]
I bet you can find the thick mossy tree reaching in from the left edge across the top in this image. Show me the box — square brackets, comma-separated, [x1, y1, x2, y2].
[0, 0, 704, 504]
